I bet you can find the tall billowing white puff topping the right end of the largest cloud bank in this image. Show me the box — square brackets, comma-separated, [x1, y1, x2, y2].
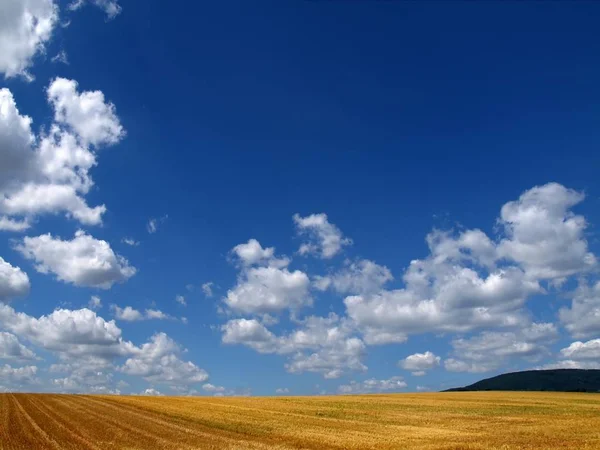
[498, 183, 597, 279]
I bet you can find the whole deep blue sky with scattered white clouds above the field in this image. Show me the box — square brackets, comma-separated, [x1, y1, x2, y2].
[0, 0, 600, 396]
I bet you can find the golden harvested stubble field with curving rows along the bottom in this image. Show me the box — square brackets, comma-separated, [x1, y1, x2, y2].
[0, 392, 600, 450]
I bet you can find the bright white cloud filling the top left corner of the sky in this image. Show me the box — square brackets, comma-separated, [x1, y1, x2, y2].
[0, 0, 58, 78]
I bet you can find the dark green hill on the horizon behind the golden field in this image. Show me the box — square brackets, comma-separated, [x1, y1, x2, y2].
[444, 369, 600, 392]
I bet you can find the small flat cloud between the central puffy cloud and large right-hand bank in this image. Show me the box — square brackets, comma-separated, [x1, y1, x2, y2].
[313, 259, 394, 294]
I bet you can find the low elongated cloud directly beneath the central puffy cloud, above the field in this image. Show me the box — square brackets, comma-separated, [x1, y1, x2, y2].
[222, 314, 367, 378]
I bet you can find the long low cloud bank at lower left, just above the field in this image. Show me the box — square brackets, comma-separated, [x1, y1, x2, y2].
[0, 304, 208, 393]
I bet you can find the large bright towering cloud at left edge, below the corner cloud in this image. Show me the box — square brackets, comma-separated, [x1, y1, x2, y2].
[0, 78, 124, 227]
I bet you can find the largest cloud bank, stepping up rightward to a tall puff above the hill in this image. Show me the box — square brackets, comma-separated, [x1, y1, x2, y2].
[340, 183, 600, 344]
